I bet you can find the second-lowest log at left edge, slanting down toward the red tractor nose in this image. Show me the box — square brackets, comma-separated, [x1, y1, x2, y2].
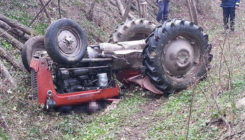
[0, 47, 26, 71]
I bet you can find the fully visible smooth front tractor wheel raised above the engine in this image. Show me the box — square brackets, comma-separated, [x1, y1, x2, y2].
[44, 19, 87, 65]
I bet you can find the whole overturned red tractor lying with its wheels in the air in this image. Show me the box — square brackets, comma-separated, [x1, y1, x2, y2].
[22, 19, 212, 110]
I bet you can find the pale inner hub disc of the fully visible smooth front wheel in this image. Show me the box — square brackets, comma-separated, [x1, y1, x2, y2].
[58, 30, 78, 54]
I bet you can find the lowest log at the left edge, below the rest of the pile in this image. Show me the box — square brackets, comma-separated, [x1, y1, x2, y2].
[0, 60, 16, 92]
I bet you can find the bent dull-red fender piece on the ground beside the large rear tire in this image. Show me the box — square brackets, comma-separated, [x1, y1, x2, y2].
[127, 74, 163, 94]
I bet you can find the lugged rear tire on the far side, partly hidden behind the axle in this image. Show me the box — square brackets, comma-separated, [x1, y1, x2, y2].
[109, 19, 156, 43]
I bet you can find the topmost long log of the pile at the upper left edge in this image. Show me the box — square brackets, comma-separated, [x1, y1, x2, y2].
[0, 14, 35, 36]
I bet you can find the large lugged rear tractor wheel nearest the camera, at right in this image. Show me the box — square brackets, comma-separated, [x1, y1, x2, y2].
[143, 19, 212, 94]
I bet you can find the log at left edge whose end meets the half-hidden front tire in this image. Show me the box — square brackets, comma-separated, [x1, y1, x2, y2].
[0, 28, 24, 50]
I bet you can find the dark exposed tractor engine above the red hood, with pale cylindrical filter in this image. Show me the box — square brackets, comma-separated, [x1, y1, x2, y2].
[54, 63, 112, 94]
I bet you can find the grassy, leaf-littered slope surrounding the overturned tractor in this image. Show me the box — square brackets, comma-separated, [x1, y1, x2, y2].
[0, 0, 245, 140]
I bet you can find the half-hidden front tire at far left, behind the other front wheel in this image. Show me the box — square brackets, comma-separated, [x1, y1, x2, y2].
[21, 36, 46, 72]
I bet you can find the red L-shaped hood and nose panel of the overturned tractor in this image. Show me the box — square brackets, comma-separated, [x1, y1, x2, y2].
[32, 58, 119, 106]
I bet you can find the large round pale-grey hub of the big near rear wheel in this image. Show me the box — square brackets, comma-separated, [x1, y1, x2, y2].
[162, 39, 195, 77]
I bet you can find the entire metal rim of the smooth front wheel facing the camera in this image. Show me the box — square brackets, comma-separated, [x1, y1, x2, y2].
[57, 27, 82, 56]
